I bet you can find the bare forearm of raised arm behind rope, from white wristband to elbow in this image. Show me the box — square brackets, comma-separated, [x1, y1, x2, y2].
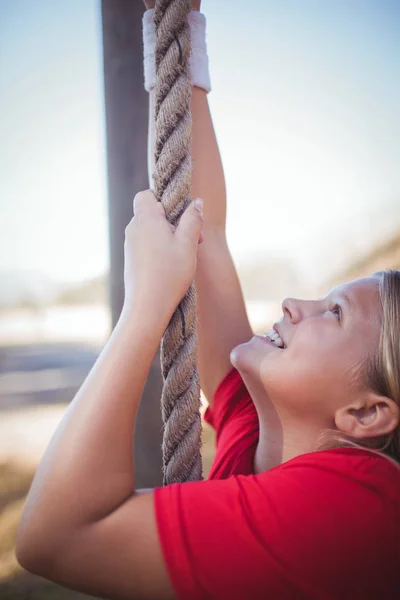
[149, 87, 226, 231]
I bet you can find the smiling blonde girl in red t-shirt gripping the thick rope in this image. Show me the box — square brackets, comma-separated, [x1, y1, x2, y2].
[17, 0, 400, 600]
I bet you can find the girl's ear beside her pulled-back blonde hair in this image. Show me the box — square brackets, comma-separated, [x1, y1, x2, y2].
[335, 391, 400, 439]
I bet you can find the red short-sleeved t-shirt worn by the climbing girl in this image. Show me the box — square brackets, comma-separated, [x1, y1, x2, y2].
[154, 369, 400, 600]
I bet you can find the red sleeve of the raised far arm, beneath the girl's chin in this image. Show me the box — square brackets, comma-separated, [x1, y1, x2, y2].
[204, 368, 259, 479]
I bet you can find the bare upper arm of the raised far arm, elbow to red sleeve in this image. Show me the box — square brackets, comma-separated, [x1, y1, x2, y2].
[196, 228, 253, 404]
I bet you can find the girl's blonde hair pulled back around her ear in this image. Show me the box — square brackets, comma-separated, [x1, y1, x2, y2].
[316, 269, 400, 468]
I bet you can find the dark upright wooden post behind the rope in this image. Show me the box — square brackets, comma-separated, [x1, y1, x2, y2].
[101, 0, 162, 488]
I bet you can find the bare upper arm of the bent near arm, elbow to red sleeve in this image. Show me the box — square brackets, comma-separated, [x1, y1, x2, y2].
[28, 491, 176, 600]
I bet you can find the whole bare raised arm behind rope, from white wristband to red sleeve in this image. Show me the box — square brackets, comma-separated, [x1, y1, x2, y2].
[152, 87, 252, 403]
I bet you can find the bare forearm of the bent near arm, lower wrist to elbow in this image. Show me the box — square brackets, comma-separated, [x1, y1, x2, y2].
[18, 306, 168, 548]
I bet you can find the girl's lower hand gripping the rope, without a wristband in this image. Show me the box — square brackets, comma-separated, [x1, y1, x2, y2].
[124, 190, 203, 324]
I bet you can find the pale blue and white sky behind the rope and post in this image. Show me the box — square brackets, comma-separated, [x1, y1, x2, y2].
[0, 0, 400, 288]
